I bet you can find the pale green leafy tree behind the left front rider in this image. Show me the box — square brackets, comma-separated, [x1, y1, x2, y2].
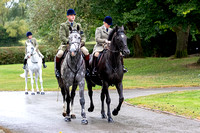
[27, 0, 81, 46]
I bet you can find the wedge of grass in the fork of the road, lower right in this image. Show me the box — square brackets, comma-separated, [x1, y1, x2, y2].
[126, 90, 200, 120]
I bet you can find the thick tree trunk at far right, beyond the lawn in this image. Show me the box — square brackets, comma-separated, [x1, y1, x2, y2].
[173, 26, 190, 58]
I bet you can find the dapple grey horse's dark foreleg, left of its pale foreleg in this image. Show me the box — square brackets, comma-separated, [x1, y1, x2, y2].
[65, 87, 71, 122]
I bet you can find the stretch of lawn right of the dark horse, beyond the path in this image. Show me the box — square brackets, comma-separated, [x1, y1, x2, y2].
[123, 57, 200, 88]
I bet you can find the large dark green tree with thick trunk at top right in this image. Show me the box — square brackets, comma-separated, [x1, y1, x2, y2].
[125, 0, 200, 58]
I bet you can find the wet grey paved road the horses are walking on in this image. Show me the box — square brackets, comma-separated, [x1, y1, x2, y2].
[0, 87, 200, 133]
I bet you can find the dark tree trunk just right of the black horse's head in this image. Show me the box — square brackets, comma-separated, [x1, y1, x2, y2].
[128, 22, 143, 57]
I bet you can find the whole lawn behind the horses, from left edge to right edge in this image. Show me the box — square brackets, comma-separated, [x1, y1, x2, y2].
[0, 57, 200, 91]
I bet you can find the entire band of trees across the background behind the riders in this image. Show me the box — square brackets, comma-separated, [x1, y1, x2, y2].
[0, 0, 200, 57]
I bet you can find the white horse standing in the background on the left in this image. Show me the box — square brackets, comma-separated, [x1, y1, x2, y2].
[24, 42, 45, 95]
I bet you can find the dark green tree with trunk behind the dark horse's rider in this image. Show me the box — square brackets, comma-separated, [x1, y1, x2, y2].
[76, 0, 143, 57]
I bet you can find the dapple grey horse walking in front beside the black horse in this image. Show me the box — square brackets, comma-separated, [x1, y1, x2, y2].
[54, 27, 88, 124]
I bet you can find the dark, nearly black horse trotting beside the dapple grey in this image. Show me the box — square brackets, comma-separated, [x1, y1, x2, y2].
[86, 26, 130, 122]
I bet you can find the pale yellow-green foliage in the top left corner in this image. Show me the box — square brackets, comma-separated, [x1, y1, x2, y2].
[0, 0, 28, 46]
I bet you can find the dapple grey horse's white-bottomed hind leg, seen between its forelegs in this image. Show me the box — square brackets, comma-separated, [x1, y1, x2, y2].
[71, 83, 77, 119]
